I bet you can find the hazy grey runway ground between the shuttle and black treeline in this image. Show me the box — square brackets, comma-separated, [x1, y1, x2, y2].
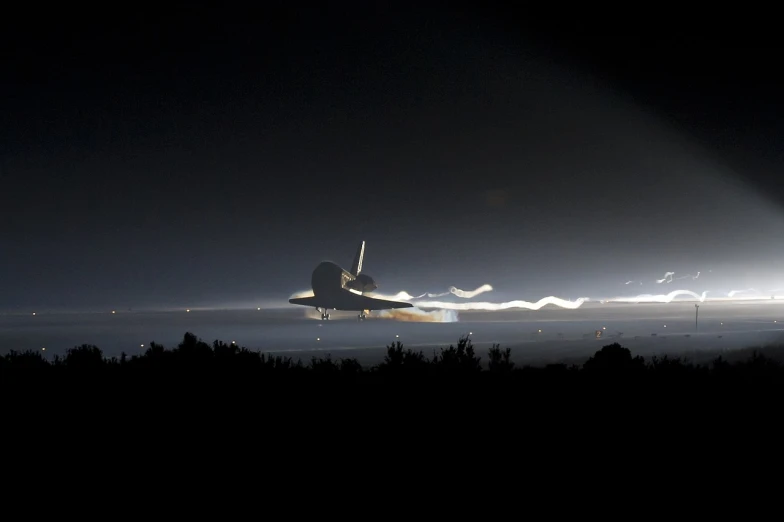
[0, 301, 784, 365]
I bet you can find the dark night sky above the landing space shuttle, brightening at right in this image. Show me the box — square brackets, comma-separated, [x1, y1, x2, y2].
[0, 3, 784, 309]
